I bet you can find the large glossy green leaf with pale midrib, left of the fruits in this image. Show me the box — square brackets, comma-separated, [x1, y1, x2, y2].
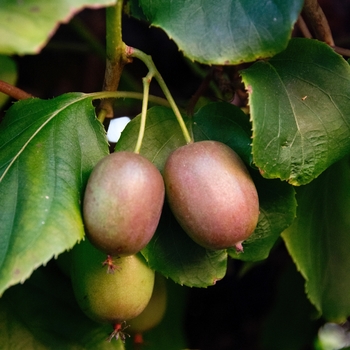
[0, 93, 108, 294]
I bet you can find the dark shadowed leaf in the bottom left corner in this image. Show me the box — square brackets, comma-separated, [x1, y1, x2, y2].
[0, 263, 124, 350]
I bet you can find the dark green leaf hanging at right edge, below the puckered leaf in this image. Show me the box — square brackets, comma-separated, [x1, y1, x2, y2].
[282, 157, 350, 322]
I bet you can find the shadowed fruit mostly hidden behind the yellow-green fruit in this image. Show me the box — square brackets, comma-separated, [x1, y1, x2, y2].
[128, 273, 167, 334]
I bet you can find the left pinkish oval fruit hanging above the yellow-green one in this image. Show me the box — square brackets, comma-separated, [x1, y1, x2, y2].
[83, 151, 165, 256]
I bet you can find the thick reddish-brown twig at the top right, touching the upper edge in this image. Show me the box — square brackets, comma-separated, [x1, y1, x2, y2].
[303, 0, 334, 47]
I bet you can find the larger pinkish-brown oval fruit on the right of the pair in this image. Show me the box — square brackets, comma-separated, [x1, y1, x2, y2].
[163, 141, 259, 251]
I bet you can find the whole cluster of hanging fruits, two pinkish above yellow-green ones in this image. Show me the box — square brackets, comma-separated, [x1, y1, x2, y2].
[71, 141, 259, 340]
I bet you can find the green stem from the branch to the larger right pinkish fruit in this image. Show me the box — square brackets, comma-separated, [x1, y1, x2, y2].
[126, 46, 193, 143]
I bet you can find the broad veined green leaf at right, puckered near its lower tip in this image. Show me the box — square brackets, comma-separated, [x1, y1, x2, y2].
[241, 38, 350, 185]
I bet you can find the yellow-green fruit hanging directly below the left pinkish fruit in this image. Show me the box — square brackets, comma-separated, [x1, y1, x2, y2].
[71, 240, 154, 324]
